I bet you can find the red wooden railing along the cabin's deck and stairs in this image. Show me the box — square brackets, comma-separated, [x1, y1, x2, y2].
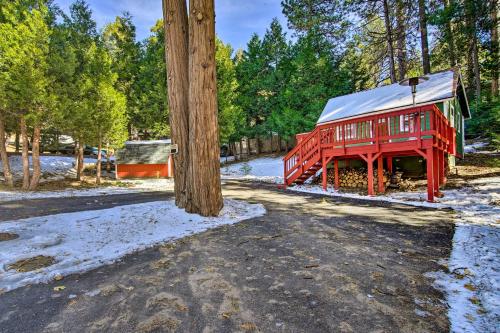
[284, 104, 455, 184]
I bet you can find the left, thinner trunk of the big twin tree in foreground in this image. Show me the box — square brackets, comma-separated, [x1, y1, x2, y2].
[163, 0, 191, 208]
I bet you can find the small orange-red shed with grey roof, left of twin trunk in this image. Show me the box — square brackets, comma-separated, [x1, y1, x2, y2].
[115, 139, 176, 179]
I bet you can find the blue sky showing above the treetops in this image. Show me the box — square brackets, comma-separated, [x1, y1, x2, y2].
[55, 0, 290, 49]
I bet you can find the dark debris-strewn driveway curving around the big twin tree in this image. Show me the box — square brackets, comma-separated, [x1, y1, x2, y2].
[0, 182, 453, 332]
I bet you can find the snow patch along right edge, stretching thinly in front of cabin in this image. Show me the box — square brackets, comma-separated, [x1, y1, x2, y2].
[289, 177, 500, 333]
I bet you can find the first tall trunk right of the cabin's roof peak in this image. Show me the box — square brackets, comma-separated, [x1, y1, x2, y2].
[465, 0, 481, 102]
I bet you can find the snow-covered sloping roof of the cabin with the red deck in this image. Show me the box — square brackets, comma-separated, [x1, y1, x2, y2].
[317, 69, 460, 124]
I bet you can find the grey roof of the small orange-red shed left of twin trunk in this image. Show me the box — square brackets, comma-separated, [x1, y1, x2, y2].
[116, 140, 172, 164]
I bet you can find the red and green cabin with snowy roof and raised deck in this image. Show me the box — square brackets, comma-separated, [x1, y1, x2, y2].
[284, 68, 470, 202]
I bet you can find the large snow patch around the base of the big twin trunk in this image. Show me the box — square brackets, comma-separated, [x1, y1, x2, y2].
[0, 199, 266, 290]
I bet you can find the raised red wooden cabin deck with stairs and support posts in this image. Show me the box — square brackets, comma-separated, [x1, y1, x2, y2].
[284, 104, 456, 201]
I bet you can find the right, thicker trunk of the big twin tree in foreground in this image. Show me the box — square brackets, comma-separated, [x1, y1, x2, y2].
[186, 0, 224, 216]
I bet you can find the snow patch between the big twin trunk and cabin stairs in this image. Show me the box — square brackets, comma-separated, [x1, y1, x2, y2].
[221, 156, 283, 183]
